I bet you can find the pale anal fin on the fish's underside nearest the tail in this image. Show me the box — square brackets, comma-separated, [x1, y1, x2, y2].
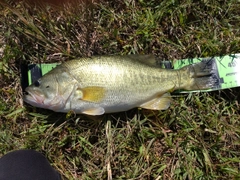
[140, 93, 172, 110]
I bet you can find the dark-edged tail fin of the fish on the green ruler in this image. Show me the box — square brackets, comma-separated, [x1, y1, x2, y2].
[182, 59, 220, 90]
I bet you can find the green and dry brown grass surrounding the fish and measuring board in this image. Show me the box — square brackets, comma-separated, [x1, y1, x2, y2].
[0, 0, 240, 180]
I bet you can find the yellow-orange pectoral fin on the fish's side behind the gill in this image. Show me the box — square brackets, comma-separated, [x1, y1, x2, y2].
[75, 86, 106, 102]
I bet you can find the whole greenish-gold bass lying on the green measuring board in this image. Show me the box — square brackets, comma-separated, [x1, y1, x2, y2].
[23, 55, 217, 116]
